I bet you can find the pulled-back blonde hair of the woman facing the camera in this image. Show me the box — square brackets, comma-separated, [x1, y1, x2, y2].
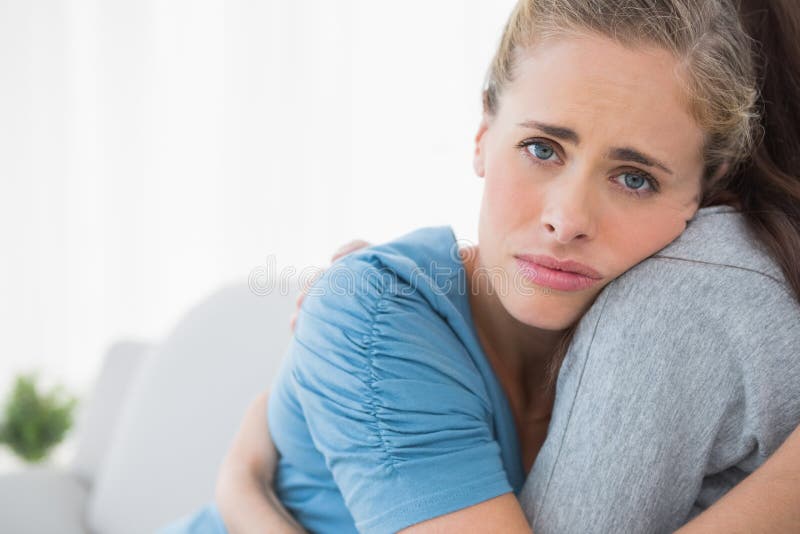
[483, 0, 759, 188]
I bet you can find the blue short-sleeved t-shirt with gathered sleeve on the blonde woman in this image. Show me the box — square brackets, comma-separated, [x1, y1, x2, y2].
[268, 226, 525, 533]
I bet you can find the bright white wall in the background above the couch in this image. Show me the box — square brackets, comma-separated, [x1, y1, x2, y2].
[0, 0, 513, 402]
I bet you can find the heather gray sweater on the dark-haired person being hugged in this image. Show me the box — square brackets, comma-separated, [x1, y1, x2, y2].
[521, 210, 800, 534]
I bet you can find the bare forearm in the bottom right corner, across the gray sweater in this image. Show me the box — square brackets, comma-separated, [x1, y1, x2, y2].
[678, 427, 800, 534]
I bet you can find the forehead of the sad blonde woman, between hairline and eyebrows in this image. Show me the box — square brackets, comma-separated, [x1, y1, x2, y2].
[500, 36, 703, 163]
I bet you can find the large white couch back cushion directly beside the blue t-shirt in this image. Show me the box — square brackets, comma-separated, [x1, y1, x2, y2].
[89, 284, 295, 534]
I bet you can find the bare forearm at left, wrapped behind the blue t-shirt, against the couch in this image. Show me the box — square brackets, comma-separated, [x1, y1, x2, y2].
[215, 393, 303, 534]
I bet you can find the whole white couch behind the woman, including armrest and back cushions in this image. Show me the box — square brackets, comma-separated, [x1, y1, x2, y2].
[0, 283, 296, 534]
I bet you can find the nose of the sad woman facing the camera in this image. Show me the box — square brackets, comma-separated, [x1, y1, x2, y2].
[541, 175, 596, 243]
